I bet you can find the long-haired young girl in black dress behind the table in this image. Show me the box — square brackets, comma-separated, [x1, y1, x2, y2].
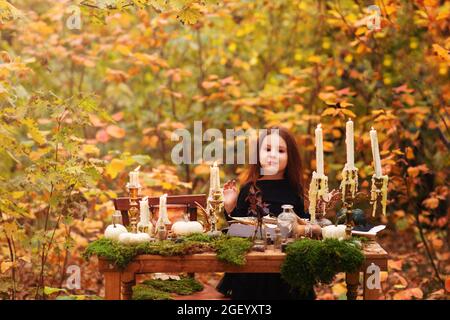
[218, 127, 321, 300]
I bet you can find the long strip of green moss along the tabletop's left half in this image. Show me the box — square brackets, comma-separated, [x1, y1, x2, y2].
[83, 234, 251, 269]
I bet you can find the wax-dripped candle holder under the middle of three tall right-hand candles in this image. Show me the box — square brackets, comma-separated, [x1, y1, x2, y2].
[341, 168, 358, 238]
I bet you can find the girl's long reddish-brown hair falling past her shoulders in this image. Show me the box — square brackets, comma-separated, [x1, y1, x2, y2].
[239, 126, 305, 198]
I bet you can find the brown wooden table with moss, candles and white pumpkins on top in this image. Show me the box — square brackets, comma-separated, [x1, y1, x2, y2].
[99, 241, 388, 300]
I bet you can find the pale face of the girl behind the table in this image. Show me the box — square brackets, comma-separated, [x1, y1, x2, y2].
[259, 133, 288, 175]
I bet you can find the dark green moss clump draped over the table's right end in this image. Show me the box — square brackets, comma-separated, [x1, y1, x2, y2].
[281, 239, 364, 294]
